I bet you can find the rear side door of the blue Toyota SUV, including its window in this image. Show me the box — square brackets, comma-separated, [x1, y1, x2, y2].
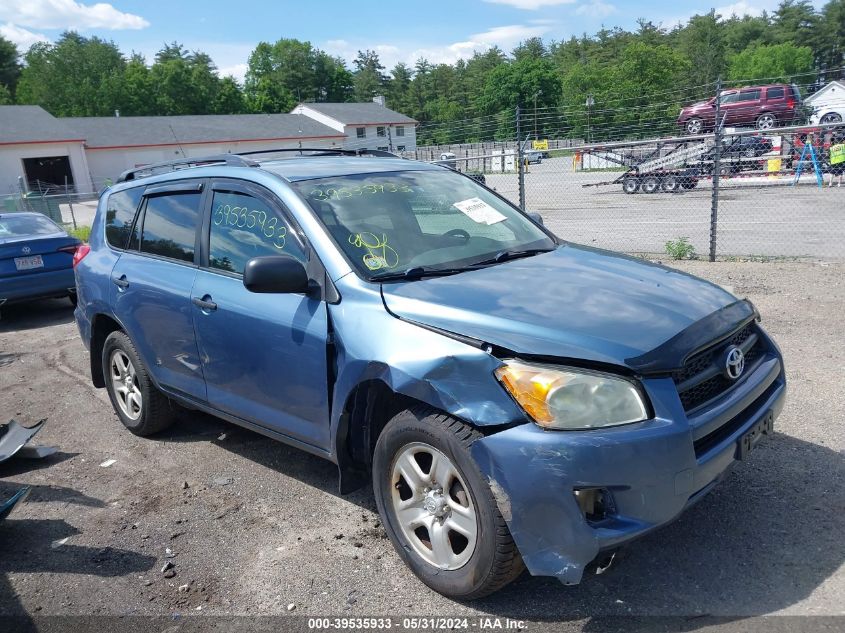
[111, 180, 206, 400]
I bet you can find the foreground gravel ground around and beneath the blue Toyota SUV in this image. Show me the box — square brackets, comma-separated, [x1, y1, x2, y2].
[0, 262, 845, 630]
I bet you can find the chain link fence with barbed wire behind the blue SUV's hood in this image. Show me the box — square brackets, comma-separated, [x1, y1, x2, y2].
[417, 113, 845, 259]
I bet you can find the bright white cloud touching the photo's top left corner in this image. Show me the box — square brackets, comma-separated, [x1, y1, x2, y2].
[0, 0, 150, 30]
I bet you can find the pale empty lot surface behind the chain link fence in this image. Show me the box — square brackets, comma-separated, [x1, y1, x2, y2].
[487, 157, 845, 258]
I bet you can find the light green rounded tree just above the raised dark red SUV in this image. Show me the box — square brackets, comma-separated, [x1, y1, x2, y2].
[728, 43, 813, 83]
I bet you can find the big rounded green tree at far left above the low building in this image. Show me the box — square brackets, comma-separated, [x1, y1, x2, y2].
[15, 31, 126, 116]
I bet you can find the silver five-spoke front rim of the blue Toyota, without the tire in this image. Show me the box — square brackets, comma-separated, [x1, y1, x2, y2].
[391, 442, 478, 570]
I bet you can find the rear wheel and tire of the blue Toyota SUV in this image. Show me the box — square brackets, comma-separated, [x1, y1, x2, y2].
[102, 331, 176, 437]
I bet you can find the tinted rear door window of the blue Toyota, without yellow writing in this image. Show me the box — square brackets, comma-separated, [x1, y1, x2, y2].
[140, 192, 202, 262]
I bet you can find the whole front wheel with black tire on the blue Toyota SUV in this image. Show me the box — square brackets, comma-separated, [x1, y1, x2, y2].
[373, 407, 524, 600]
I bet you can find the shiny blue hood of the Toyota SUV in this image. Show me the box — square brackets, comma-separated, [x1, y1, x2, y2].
[382, 244, 737, 368]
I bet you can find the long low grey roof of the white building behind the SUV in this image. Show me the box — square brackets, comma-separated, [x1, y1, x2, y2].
[61, 114, 345, 148]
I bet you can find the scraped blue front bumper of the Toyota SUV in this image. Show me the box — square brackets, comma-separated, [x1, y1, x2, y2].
[472, 358, 786, 584]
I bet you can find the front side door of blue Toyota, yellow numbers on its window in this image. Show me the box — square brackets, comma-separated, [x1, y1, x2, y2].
[192, 175, 329, 448]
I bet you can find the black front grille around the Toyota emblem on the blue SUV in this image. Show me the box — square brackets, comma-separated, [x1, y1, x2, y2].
[672, 322, 763, 411]
